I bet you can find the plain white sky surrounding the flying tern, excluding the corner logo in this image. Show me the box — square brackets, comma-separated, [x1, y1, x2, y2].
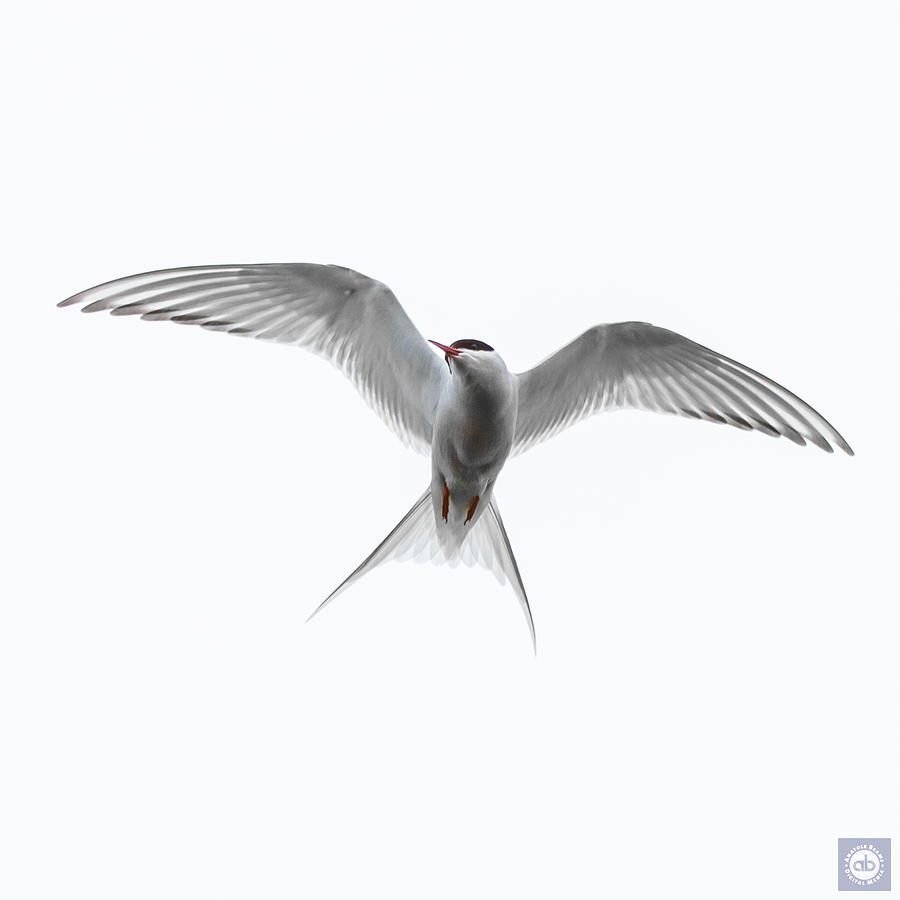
[0, 0, 900, 900]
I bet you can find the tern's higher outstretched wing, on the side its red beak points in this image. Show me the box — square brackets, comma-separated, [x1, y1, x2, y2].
[59, 263, 448, 453]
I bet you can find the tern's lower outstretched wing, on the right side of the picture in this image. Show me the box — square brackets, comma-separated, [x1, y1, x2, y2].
[512, 322, 853, 456]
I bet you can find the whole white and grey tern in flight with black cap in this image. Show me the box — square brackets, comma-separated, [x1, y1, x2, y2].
[58, 263, 853, 652]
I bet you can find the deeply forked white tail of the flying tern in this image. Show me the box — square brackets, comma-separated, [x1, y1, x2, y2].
[307, 489, 537, 653]
